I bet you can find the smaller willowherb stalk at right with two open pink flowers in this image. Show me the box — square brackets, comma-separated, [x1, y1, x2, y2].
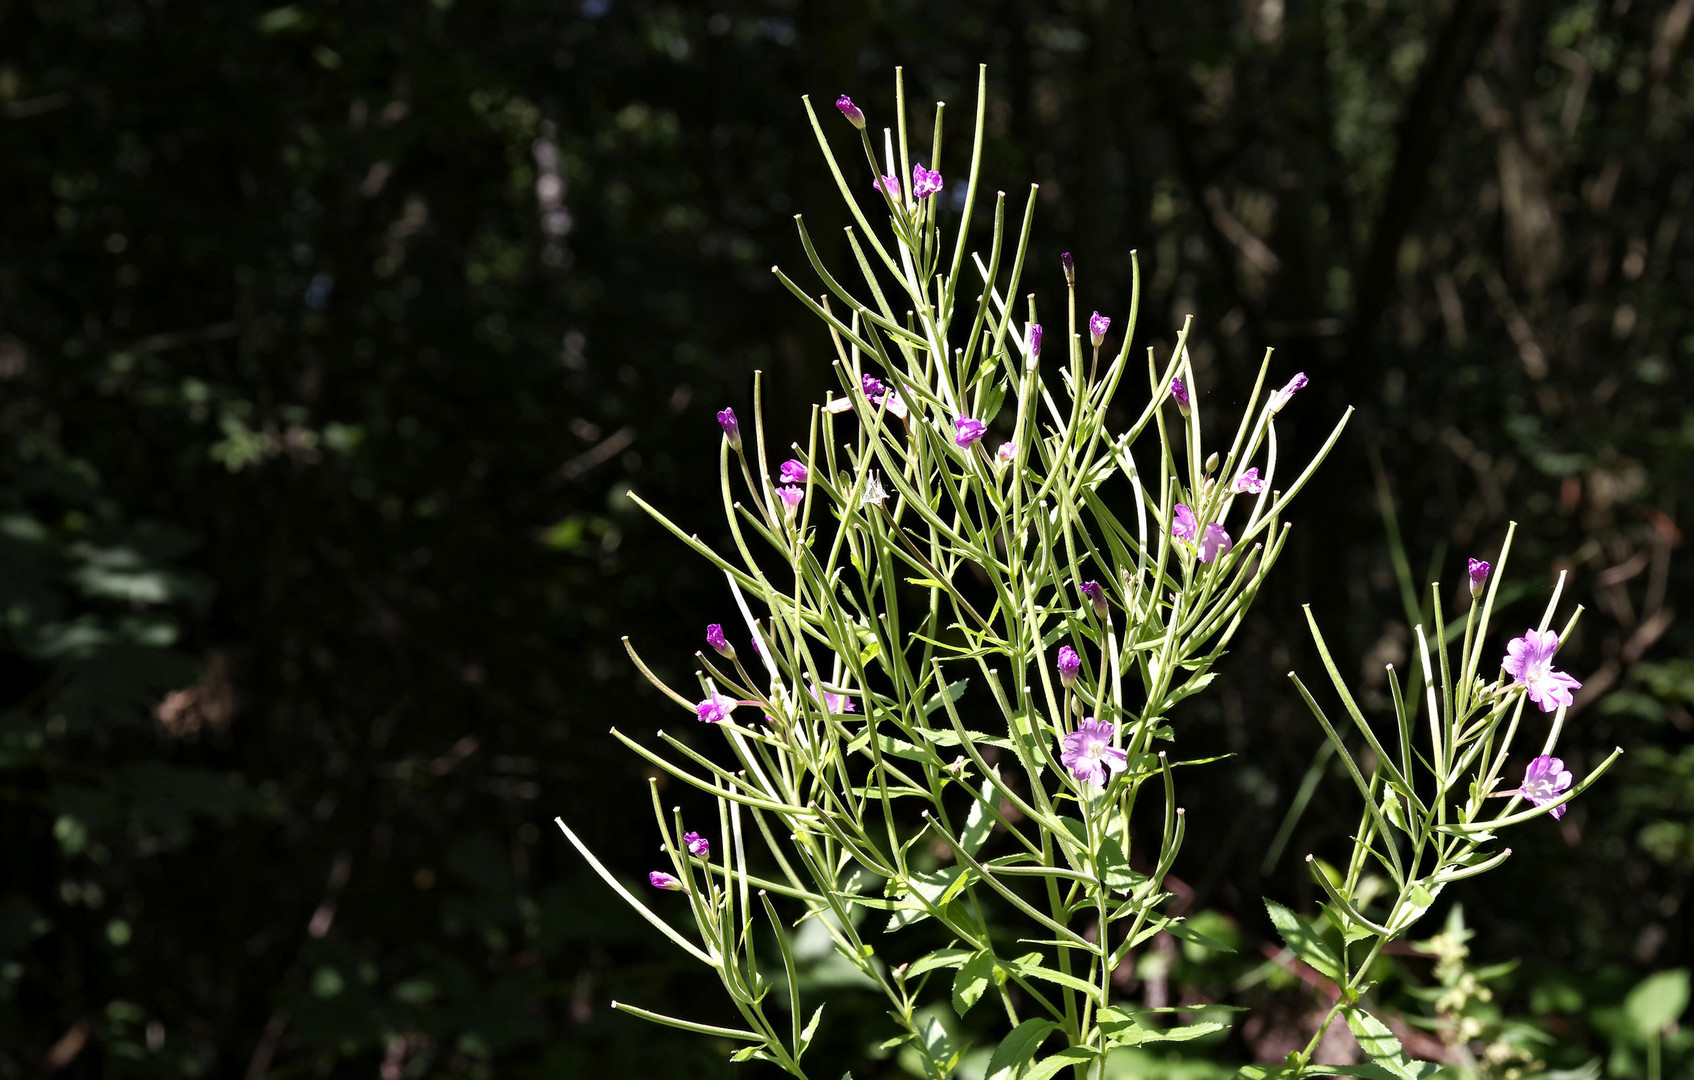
[1255, 528, 1623, 1077]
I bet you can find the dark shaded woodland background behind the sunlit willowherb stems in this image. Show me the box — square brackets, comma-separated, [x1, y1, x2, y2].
[0, 0, 1694, 1078]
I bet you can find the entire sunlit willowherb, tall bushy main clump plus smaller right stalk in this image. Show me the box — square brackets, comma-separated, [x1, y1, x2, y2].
[559, 67, 1612, 1080]
